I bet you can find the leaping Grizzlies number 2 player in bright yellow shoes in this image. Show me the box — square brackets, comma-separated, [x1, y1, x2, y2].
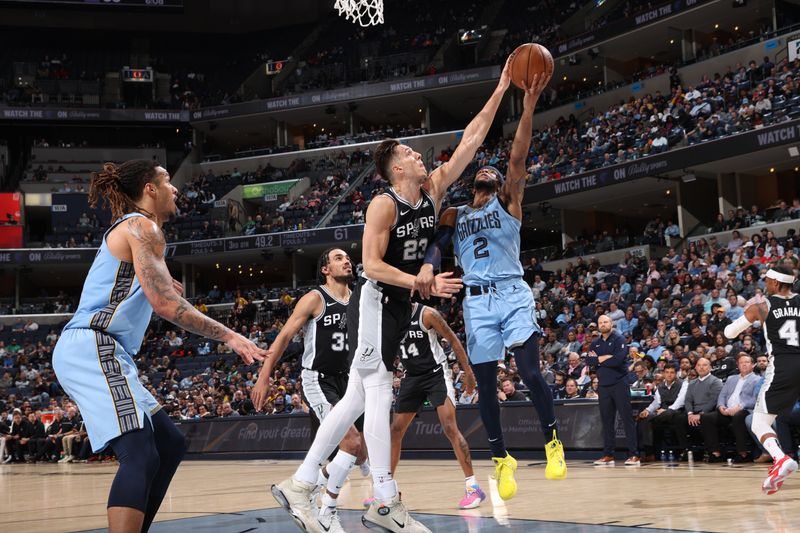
[420, 75, 567, 500]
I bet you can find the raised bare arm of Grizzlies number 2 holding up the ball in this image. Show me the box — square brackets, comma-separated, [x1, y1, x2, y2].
[500, 74, 550, 210]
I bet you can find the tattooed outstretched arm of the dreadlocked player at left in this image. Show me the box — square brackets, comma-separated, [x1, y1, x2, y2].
[126, 217, 265, 365]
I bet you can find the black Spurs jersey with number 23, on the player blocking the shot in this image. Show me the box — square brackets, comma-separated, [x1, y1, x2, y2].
[379, 188, 436, 300]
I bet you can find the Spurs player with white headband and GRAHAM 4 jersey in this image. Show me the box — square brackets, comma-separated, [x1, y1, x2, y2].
[725, 266, 800, 494]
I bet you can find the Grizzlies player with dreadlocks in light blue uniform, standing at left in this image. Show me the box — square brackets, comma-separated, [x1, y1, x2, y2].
[53, 160, 266, 533]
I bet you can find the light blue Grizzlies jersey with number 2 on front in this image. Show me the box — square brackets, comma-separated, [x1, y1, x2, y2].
[453, 195, 522, 285]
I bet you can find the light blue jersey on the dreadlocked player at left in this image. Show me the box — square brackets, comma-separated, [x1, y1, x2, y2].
[64, 213, 153, 355]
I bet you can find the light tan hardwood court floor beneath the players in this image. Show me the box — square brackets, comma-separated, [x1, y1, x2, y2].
[0, 460, 800, 533]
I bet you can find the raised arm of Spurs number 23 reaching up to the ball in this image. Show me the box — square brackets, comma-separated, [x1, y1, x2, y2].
[428, 57, 511, 205]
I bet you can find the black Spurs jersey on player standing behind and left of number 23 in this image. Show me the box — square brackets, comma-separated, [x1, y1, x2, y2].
[303, 285, 350, 374]
